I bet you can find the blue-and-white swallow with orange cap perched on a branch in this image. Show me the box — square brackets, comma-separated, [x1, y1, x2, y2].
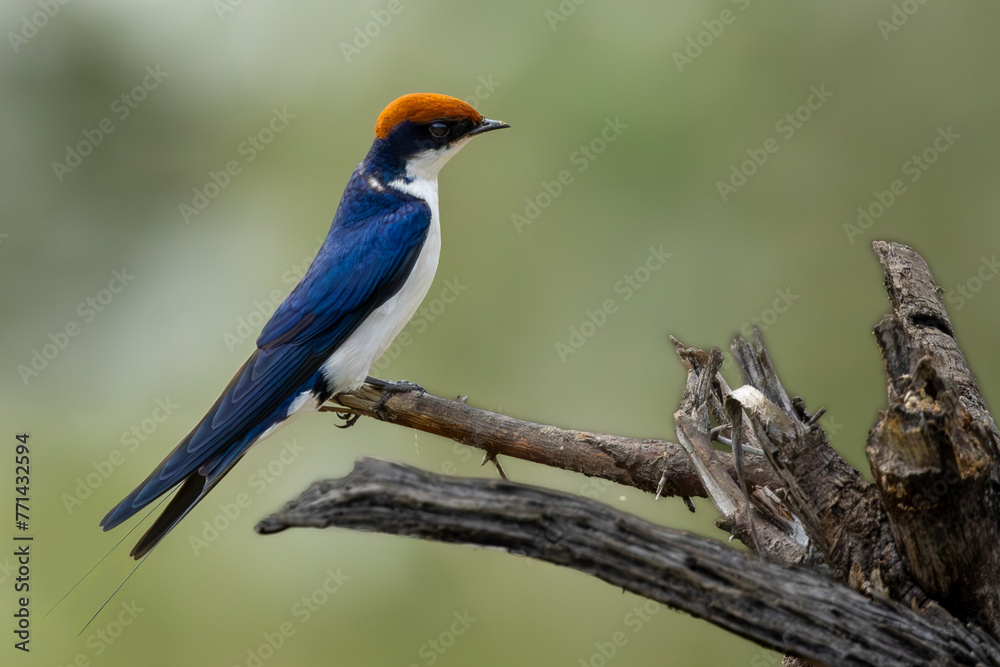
[100, 93, 510, 560]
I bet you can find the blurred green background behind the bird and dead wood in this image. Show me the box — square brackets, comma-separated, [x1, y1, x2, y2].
[0, 0, 1000, 667]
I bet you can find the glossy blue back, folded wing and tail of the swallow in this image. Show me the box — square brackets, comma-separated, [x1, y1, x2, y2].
[101, 170, 431, 558]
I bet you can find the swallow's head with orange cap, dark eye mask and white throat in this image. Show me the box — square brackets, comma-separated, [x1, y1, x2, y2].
[368, 93, 510, 180]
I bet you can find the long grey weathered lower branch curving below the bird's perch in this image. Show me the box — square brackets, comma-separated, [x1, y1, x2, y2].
[257, 459, 1000, 667]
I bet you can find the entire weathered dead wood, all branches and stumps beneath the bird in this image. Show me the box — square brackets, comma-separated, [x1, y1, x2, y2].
[258, 242, 1000, 665]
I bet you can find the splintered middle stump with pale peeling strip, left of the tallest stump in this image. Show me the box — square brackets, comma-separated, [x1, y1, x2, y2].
[674, 332, 929, 609]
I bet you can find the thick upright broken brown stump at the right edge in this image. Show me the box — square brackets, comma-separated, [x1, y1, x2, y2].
[867, 241, 1000, 637]
